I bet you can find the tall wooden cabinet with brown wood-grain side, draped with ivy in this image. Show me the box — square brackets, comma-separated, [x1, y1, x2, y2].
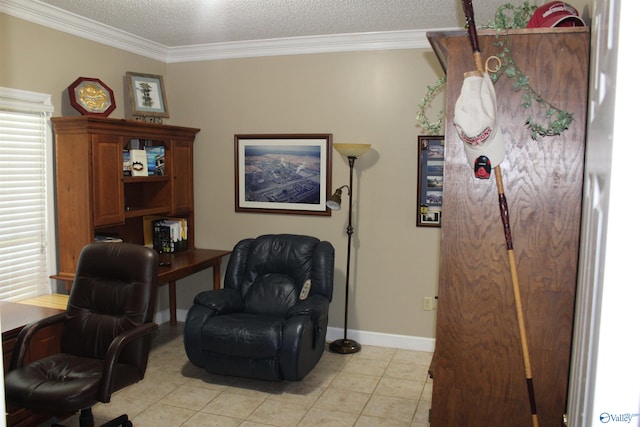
[427, 28, 589, 427]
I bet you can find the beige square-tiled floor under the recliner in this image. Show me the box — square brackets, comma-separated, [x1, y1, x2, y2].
[52, 324, 432, 427]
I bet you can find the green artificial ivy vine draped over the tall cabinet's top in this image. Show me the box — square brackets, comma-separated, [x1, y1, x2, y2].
[416, 1, 573, 140]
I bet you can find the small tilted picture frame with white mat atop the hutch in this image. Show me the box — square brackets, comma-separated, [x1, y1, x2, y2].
[126, 71, 169, 118]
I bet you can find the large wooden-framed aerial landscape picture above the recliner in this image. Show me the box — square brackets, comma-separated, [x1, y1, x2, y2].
[234, 133, 333, 216]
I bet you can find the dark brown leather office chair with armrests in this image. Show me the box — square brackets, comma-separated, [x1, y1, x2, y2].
[5, 243, 158, 427]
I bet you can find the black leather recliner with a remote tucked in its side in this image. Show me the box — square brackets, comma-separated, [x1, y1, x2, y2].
[184, 234, 334, 381]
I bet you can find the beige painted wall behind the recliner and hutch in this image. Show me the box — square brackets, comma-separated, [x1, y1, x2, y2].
[0, 14, 441, 337]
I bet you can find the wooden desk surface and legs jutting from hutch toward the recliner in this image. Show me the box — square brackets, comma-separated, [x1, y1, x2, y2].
[158, 249, 231, 325]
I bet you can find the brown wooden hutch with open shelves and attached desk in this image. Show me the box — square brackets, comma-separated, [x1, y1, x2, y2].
[51, 116, 230, 324]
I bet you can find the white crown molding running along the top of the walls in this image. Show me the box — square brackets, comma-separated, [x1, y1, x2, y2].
[0, 0, 450, 63]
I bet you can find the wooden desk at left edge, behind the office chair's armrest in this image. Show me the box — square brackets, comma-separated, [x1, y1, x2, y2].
[0, 301, 64, 426]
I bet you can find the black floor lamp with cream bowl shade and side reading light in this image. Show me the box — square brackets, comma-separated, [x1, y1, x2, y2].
[327, 144, 371, 354]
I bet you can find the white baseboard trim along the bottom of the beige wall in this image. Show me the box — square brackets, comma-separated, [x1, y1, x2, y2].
[154, 309, 436, 352]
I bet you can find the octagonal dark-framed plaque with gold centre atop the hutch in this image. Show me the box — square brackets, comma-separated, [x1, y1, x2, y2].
[67, 77, 116, 117]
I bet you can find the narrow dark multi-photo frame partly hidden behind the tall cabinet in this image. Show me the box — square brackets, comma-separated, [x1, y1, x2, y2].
[416, 135, 444, 227]
